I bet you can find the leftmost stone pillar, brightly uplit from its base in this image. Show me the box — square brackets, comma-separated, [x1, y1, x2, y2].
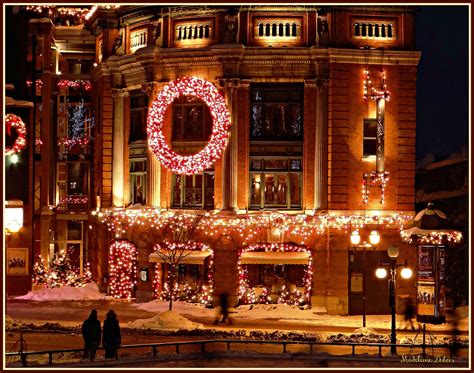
[112, 89, 128, 207]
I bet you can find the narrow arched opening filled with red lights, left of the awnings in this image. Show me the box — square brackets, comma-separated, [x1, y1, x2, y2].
[109, 240, 137, 299]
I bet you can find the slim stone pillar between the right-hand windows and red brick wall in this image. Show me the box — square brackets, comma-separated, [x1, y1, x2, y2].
[314, 79, 328, 210]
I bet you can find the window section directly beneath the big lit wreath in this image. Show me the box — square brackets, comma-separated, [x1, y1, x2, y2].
[172, 170, 214, 209]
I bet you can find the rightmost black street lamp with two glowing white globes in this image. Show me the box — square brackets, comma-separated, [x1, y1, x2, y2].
[375, 246, 413, 355]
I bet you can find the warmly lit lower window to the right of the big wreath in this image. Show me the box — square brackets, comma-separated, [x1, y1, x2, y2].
[250, 158, 303, 209]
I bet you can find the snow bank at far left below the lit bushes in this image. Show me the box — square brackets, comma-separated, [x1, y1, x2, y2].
[15, 282, 107, 301]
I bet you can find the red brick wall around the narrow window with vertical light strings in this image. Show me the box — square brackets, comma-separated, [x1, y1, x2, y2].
[328, 64, 416, 211]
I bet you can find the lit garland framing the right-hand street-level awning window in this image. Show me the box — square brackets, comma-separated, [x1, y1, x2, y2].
[237, 243, 313, 305]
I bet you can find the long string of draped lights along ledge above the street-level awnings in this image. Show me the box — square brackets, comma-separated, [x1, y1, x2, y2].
[92, 208, 413, 246]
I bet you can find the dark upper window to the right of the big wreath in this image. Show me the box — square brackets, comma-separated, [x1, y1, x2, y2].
[250, 84, 304, 141]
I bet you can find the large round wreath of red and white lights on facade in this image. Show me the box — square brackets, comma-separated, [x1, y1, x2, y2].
[147, 77, 230, 175]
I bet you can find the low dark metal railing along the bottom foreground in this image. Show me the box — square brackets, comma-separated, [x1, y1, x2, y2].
[5, 339, 469, 367]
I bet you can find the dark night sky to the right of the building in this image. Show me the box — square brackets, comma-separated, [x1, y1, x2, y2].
[415, 6, 469, 160]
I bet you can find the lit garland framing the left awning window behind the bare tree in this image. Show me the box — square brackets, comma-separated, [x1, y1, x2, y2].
[153, 241, 214, 304]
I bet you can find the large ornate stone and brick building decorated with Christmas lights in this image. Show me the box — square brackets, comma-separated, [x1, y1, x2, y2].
[7, 6, 420, 314]
